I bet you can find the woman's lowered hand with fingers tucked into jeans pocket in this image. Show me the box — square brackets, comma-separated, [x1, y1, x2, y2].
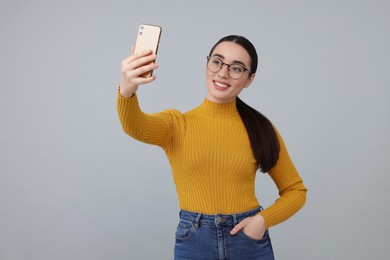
[230, 215, 265, 240]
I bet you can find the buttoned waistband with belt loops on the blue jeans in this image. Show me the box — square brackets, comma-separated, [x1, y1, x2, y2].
[179, 206, 263, 226]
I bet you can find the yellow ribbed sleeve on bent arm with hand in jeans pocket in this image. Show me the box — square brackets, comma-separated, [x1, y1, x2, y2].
[259, 129, 307, 229]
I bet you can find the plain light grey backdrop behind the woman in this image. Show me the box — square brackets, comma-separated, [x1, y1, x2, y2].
[0, 0, 390, 260]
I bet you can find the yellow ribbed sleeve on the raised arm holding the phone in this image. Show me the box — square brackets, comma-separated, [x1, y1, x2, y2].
[117, 91, 179, 148]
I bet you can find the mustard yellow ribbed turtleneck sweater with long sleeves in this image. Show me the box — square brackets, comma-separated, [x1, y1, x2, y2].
[117, 92, 306, 228]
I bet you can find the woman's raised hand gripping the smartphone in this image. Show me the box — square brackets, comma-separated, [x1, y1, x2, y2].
[119, 45, 158, 97]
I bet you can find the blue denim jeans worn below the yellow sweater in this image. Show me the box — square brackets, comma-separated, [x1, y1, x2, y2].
[174, 207, 274, 260]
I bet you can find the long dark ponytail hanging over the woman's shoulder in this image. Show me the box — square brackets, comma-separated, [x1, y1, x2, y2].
[236, 97, 280, 173]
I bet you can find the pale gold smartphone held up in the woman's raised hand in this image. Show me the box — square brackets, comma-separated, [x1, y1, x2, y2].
[134, 24, 162, 78]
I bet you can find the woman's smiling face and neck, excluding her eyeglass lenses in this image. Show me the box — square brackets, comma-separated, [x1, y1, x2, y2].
[206, 41, 255, 103]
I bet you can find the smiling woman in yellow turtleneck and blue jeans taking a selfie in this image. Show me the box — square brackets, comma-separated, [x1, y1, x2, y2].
[117, 35, 306, 260]
